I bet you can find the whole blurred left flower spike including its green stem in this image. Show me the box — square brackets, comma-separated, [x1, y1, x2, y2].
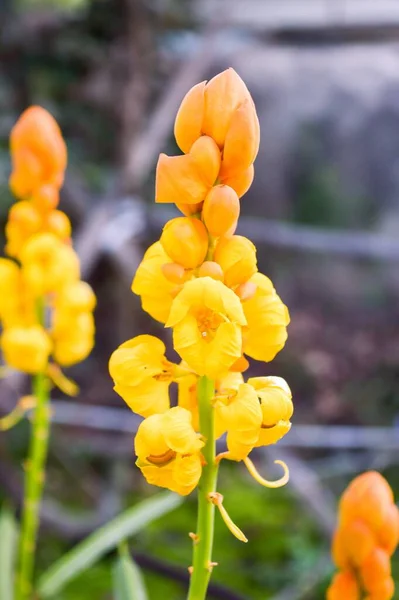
[0, 106, 96, 600]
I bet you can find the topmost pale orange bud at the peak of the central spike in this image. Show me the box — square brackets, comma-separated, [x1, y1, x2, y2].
[202, 68, 251, 149]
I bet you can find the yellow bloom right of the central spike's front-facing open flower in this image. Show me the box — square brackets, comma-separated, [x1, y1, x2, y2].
[243, 273, 290, 362]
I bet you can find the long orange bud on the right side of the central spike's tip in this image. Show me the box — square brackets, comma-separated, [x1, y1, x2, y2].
[222, 99, 260, 174]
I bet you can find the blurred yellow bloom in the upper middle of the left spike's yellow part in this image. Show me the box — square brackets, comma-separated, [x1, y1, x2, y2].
[21, 233, 80, 296]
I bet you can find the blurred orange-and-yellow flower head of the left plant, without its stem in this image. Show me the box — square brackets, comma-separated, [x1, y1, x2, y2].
[0, 106, 96, 381]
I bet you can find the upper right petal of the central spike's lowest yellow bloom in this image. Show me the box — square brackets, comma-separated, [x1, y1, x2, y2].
[162, 406, 204, 454]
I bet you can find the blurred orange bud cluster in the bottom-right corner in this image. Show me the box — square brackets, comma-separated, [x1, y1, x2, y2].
[327, 471, 399, 600]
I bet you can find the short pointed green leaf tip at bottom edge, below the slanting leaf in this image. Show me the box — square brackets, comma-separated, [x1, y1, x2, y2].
[113, 547, 148, 600]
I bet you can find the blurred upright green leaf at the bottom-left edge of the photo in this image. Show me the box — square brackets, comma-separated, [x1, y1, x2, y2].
[0, 508, 18, 600]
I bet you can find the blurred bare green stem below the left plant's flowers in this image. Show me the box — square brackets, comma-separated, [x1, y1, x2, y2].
[15, 304, 50, 600]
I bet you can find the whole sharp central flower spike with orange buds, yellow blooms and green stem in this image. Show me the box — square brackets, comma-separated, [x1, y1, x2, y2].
[109, 69, 293, 600]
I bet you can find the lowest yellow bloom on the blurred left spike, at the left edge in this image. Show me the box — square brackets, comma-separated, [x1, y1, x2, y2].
[0, 325, 51, 374]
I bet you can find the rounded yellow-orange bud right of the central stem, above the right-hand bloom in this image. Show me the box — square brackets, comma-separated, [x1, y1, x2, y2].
[213, 235, 257, 287]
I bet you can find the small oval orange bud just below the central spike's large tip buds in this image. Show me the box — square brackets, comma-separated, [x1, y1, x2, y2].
[202, 185, 240, 237]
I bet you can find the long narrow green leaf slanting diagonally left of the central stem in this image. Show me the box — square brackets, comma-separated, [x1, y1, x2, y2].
[37, 493, 182, 598]
